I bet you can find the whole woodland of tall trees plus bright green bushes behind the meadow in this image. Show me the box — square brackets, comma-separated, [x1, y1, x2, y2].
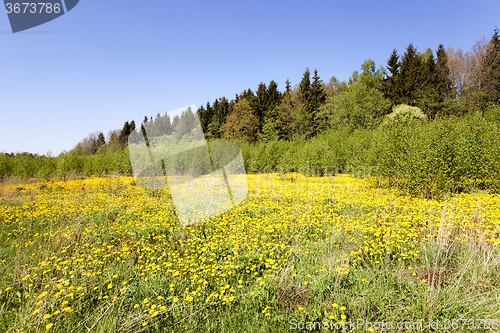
[0, 29, 500, 194]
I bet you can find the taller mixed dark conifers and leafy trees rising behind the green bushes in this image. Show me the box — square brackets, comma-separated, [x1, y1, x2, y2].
[61, 29, 500, 151]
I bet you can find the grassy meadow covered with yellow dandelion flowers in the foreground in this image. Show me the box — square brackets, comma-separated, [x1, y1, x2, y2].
[0, 173, 500, 333]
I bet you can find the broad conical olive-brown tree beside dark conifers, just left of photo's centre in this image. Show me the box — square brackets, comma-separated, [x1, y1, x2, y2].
[220, 99, 262, 143]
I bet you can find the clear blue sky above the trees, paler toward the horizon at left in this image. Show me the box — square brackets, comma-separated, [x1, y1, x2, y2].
[0, 0, 500, 155]
